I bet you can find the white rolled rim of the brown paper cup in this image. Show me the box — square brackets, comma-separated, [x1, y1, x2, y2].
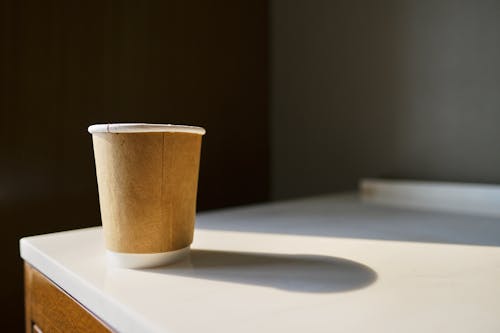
[88, 123, 206, 135]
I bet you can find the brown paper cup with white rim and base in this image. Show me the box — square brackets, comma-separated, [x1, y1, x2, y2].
[88, 124, 205, 268]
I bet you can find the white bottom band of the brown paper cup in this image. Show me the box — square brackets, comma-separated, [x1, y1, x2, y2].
[106, 246, 190, 268]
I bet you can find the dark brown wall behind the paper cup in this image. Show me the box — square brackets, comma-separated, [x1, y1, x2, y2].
[0, 0, 269, 331]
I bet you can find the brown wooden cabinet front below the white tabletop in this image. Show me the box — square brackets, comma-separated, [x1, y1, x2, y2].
[24, 263, 113, 333]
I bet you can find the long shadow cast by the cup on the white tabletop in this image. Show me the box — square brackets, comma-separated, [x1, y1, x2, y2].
[145, 250, 377, 293]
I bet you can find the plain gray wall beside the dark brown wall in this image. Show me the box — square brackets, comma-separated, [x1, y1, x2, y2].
[271, 0, 500, 199]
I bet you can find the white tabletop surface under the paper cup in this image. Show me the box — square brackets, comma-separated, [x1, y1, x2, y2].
[21, 195, 500, 333]
